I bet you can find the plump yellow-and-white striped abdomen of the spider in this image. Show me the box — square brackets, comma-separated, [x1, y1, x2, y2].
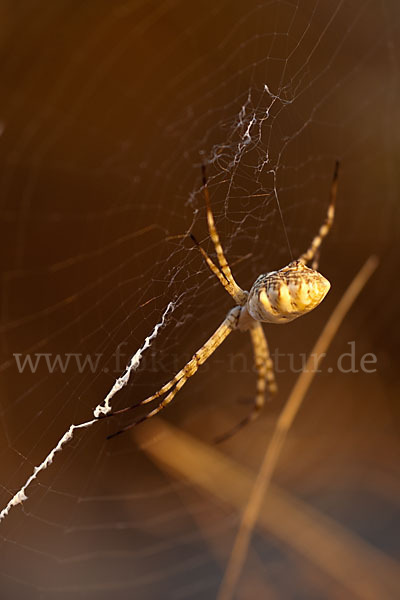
[247, 260, 331, 323]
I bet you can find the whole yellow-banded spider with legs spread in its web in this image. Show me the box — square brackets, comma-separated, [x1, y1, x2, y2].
[108, 161, 339, 443]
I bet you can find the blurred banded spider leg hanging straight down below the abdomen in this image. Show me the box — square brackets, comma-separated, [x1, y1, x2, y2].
[215, 323, 278, 444]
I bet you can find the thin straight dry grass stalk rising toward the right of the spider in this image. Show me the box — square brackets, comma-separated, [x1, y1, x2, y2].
[217, 256, 378, 600]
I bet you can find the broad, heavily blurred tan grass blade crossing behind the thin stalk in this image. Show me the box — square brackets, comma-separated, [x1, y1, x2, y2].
[132, 412, 400, 600]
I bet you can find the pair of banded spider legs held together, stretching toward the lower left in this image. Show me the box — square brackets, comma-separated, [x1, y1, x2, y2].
[107, 306, 241, 439]
